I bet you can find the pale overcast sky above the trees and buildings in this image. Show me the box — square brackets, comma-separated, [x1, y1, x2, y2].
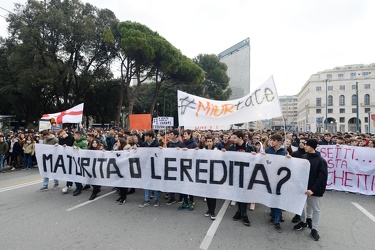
[0, 0, 375, 95]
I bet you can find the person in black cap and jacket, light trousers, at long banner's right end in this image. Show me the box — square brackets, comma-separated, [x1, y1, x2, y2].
[293, 139, 328, 241]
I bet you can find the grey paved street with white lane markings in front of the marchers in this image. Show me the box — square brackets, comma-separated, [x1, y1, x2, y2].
[0, 169, 375, 250]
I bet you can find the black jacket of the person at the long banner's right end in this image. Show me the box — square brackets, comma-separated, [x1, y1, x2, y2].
[303, 152, 328, 197]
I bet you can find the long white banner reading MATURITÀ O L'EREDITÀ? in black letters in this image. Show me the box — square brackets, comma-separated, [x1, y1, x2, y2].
[36, 144, 310, 214]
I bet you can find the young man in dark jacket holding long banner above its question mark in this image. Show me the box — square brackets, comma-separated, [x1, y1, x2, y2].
[264, 134, 291, 233]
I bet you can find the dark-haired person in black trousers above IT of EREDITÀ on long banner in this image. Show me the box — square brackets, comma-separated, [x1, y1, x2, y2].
[222, 131, 254, 227]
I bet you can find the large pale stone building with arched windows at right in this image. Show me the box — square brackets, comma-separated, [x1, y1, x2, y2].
[297, 63, 375, 133]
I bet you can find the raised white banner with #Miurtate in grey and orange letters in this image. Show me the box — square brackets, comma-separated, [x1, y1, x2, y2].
[177, 77, 282, 127]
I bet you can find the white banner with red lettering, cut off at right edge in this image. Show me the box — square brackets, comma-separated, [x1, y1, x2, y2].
[317, 145, 375, 195]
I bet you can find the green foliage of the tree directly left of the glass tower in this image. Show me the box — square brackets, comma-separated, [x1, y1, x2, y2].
[192, 54, 232, 100]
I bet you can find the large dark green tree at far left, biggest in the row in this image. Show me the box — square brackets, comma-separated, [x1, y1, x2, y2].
[0, 0, 118, 124]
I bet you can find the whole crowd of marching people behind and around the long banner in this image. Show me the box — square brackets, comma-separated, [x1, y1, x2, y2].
[0, 125, 375, 240]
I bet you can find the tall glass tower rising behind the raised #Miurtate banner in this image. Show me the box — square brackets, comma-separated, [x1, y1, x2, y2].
[218, 38, 250, 100]
